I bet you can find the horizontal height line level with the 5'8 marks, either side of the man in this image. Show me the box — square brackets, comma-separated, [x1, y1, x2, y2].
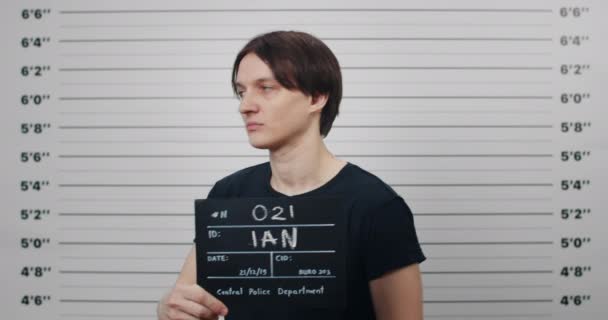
[59, 124, 553, 130]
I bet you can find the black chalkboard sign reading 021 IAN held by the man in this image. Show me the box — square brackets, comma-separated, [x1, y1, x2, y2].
[195, 197, 347, 309]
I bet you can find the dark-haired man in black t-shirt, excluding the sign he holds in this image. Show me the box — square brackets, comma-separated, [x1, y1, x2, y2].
[157, 31, 426, 320]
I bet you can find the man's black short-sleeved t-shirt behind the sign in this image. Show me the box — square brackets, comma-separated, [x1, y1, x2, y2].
[197, 162, 426, 320]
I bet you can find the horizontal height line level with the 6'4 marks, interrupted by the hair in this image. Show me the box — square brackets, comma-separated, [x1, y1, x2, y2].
[59, 37, 553, 43]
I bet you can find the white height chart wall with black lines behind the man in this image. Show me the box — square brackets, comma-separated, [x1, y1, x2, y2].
[0, 0, 608, 320]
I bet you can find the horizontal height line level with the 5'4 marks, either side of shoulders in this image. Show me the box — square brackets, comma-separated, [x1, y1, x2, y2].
[58, 183, 553, 188]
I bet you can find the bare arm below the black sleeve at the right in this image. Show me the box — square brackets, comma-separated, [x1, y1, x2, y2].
[369, 263, 423, 320]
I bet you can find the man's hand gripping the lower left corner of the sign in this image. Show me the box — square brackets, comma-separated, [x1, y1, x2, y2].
[157, 283, 228, 320]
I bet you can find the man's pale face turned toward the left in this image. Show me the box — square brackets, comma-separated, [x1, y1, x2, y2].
[236, 53, 320, 151]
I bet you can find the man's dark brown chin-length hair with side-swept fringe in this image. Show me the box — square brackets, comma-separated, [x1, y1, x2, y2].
[232, 31, 342, 137]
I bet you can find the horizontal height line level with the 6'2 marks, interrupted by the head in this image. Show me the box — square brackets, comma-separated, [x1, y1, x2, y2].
[59, 66, 553, 72]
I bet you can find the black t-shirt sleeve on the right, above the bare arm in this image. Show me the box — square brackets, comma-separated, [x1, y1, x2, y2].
[364, 196, 426, 281]
